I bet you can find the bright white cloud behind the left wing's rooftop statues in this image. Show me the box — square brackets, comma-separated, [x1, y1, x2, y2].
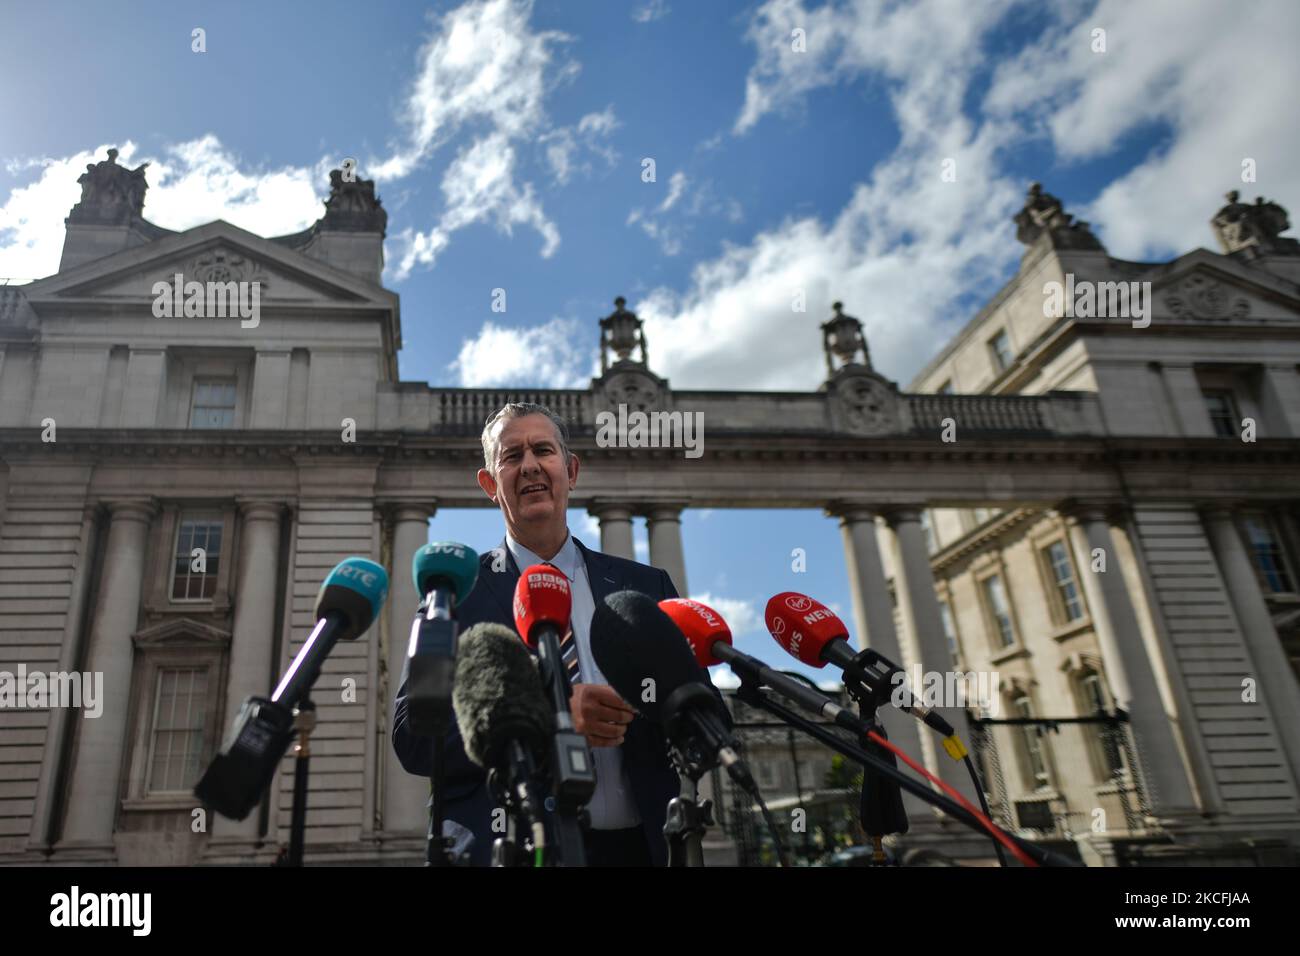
[0, 134, 325, 278]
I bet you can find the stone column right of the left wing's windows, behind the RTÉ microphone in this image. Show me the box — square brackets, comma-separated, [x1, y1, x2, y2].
[212, 501, 285, 843]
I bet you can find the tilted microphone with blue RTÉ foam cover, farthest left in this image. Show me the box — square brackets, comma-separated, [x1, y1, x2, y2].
[194, 558, 389, 819]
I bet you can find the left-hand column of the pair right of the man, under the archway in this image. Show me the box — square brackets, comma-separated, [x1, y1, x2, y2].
[827, 503, 930, 823]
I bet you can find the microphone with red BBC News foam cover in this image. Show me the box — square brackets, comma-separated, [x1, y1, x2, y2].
[515, 564, 595, 816]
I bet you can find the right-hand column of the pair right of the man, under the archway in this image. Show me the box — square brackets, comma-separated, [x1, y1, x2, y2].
[885, 507, 976, 801]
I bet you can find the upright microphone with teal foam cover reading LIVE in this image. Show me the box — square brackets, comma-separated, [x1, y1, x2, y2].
[407, 541, 478, 736]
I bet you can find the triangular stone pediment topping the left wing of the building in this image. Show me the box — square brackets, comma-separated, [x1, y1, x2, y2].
[25, 220, 397, 307]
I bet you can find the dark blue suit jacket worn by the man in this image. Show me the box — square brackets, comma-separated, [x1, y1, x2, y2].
[393, 537, 716, 866]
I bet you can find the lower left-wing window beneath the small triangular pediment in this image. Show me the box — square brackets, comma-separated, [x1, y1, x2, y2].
[146, 667, 208, 795]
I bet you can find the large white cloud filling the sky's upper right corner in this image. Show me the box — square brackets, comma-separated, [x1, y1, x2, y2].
[985, 0, 1300, 259]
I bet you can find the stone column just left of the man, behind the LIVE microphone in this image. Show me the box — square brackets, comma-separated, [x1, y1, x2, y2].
[382, 503, 437, 835]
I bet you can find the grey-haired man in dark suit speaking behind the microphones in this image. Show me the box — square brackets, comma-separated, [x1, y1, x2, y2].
[393, 403, 707, 866]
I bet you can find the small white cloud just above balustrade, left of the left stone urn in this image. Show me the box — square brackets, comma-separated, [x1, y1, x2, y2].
[449, 317, 599, 389]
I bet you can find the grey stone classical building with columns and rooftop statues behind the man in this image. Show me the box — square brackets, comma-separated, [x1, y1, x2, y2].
[0, 153, 1300, 865]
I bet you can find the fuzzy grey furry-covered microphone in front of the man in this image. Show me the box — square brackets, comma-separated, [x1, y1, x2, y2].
[451, 622, 555, 849]
